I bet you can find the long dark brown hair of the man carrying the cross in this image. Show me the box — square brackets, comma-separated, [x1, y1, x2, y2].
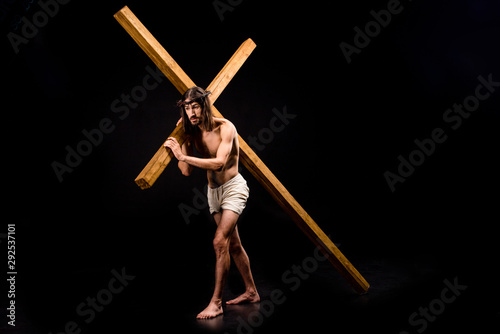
[177, 87, 214, 135]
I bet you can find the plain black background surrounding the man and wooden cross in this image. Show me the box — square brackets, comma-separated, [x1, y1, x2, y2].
[0, 0, 500, 333]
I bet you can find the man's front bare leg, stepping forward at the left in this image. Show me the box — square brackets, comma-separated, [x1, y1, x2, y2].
[196, 210, 239, 319]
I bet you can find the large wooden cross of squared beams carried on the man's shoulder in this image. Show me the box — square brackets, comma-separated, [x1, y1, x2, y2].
[114, 6, 370, 294]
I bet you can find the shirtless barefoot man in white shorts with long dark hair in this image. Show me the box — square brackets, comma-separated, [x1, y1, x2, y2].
[164, 87, 260, 319]
